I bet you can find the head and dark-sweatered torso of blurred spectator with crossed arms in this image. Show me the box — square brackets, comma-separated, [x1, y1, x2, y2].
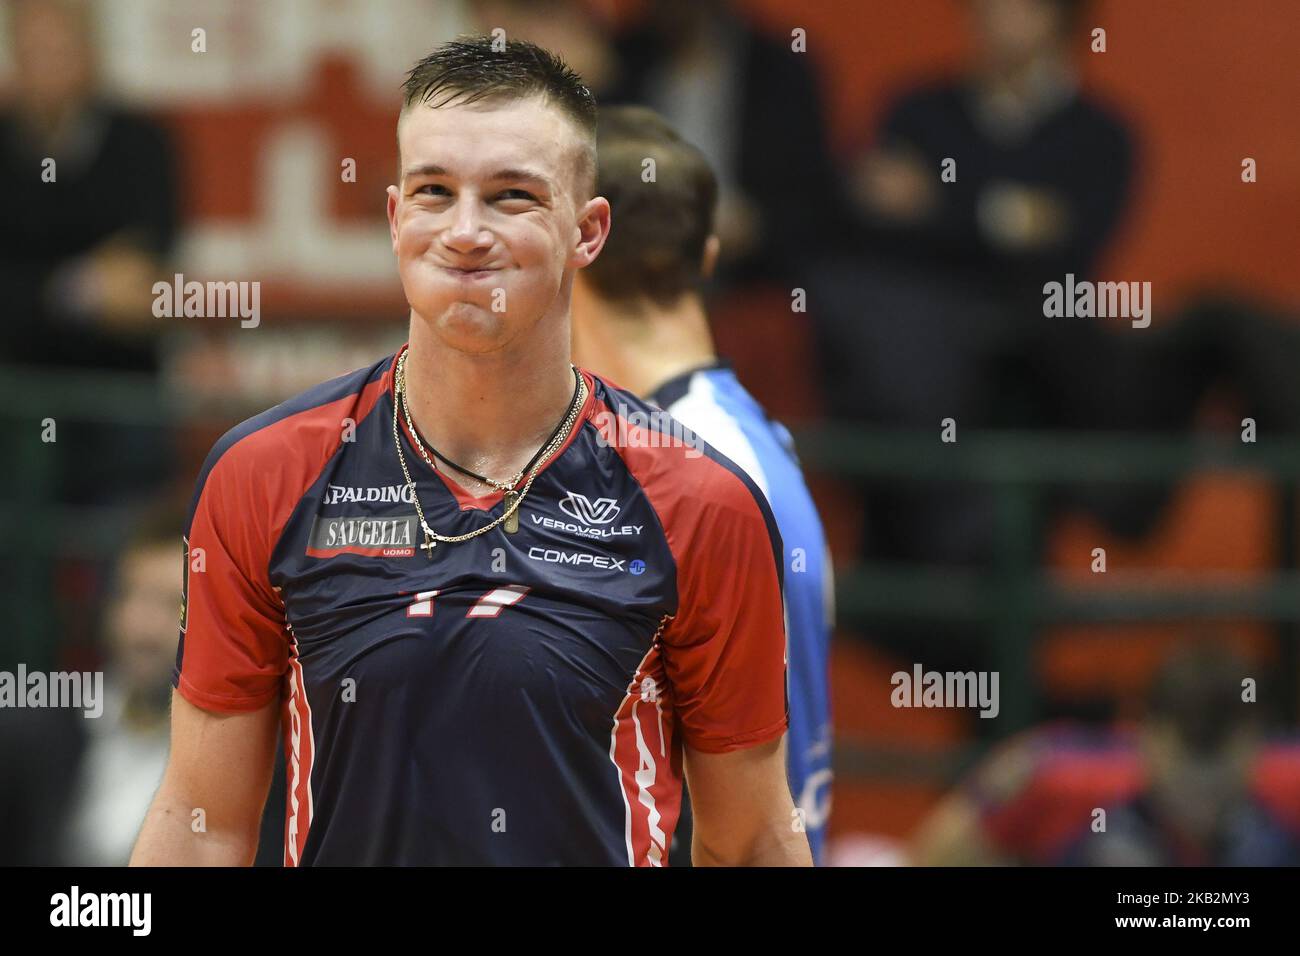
[850, 0, 1132, 300]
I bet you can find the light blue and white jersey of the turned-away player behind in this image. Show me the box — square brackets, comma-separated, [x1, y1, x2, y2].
[649, 360, 835, 864]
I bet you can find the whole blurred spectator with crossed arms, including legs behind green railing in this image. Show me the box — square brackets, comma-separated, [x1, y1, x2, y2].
[807, 0, 1134, 676]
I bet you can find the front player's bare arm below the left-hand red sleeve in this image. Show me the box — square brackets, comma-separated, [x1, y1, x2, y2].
[131, 693, 280, 866]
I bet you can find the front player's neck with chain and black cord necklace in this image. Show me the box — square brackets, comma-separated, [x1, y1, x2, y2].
[406, 315, 575, 494]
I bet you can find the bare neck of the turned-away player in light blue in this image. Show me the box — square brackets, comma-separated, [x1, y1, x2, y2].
[582, 295, 718, 397]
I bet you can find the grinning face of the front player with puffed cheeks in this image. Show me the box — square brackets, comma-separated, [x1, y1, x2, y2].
[387, 96, 610, 354]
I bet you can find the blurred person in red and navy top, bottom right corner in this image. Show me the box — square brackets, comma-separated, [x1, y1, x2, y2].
[913, 640, 1300, 866]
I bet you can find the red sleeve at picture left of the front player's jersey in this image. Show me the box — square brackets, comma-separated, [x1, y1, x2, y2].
[173, 436, 289, 713]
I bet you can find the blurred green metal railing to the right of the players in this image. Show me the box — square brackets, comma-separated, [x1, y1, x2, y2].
[794, 423, 1300, 732]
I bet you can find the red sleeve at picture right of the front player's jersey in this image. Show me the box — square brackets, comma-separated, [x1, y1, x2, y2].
[663, 458, 789, 753]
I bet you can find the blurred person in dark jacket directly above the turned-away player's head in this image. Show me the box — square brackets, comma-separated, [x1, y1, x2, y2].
[595, 0, 848, 285]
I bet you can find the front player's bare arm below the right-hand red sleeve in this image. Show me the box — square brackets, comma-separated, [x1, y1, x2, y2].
[685, 736, 813, 866]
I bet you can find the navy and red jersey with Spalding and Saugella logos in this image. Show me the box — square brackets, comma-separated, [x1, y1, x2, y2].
[173, 352, 788, 866]
